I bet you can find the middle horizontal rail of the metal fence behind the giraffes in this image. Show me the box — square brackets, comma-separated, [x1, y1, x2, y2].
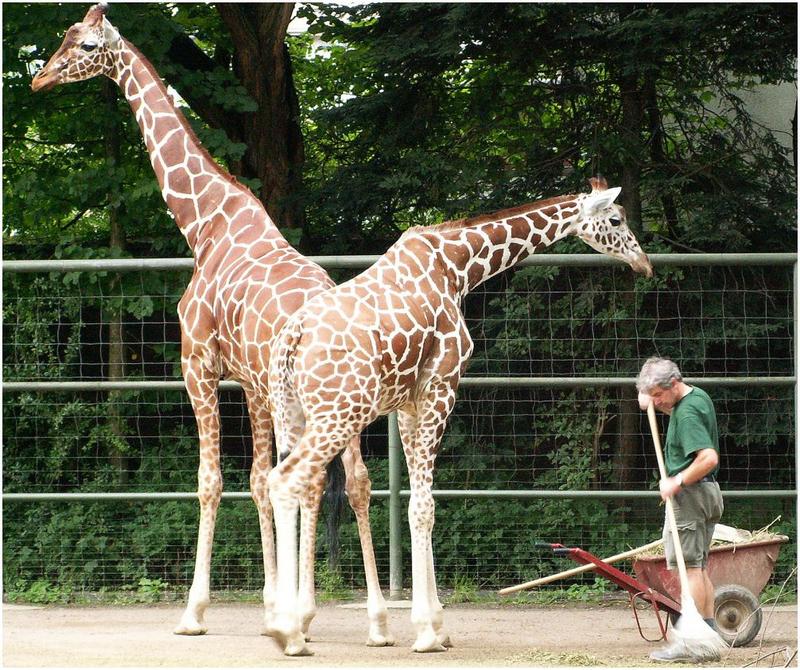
[3, 376, 797, 393]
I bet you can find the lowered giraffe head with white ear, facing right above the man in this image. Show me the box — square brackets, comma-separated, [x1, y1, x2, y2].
[570, 177, 653, 277]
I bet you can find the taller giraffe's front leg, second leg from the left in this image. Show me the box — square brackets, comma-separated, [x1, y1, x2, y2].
[245, 391, 276, 635]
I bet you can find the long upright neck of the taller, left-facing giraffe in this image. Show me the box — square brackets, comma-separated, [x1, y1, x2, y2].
[110, 39, 280, 252]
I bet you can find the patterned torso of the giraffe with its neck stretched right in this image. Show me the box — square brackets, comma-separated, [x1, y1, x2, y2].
[270, 230, 472, 425]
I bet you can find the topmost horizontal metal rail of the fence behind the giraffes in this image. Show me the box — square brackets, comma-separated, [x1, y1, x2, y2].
[3, 253, 797, 272]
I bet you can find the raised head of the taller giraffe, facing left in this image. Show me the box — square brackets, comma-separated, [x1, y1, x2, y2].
[31, 3, 121, 91]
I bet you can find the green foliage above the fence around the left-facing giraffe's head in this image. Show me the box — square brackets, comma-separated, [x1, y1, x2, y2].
[3, 4, 253, 256]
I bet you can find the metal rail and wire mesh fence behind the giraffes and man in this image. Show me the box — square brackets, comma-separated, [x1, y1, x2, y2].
[3, 254, 798, 594]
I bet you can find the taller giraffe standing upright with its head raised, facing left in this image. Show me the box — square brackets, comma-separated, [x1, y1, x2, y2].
[31, 4, 394, 646]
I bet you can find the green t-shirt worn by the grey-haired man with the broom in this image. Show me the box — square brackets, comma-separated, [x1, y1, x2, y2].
[664, 386, 719, 477]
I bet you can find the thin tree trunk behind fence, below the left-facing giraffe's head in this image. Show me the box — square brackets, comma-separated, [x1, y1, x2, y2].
[103, 79, 128, 487]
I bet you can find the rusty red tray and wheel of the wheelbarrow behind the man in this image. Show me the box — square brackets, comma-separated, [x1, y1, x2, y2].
[633, 535, 789, 647]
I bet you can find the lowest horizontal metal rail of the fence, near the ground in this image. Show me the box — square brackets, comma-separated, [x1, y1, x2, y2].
[3, 489, 797, 503]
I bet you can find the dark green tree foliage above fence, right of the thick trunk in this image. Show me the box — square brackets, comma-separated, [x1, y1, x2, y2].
[297, 3, 796, 251]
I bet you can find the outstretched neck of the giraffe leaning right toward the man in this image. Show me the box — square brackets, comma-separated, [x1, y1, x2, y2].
[431, 196, 581, 296]
